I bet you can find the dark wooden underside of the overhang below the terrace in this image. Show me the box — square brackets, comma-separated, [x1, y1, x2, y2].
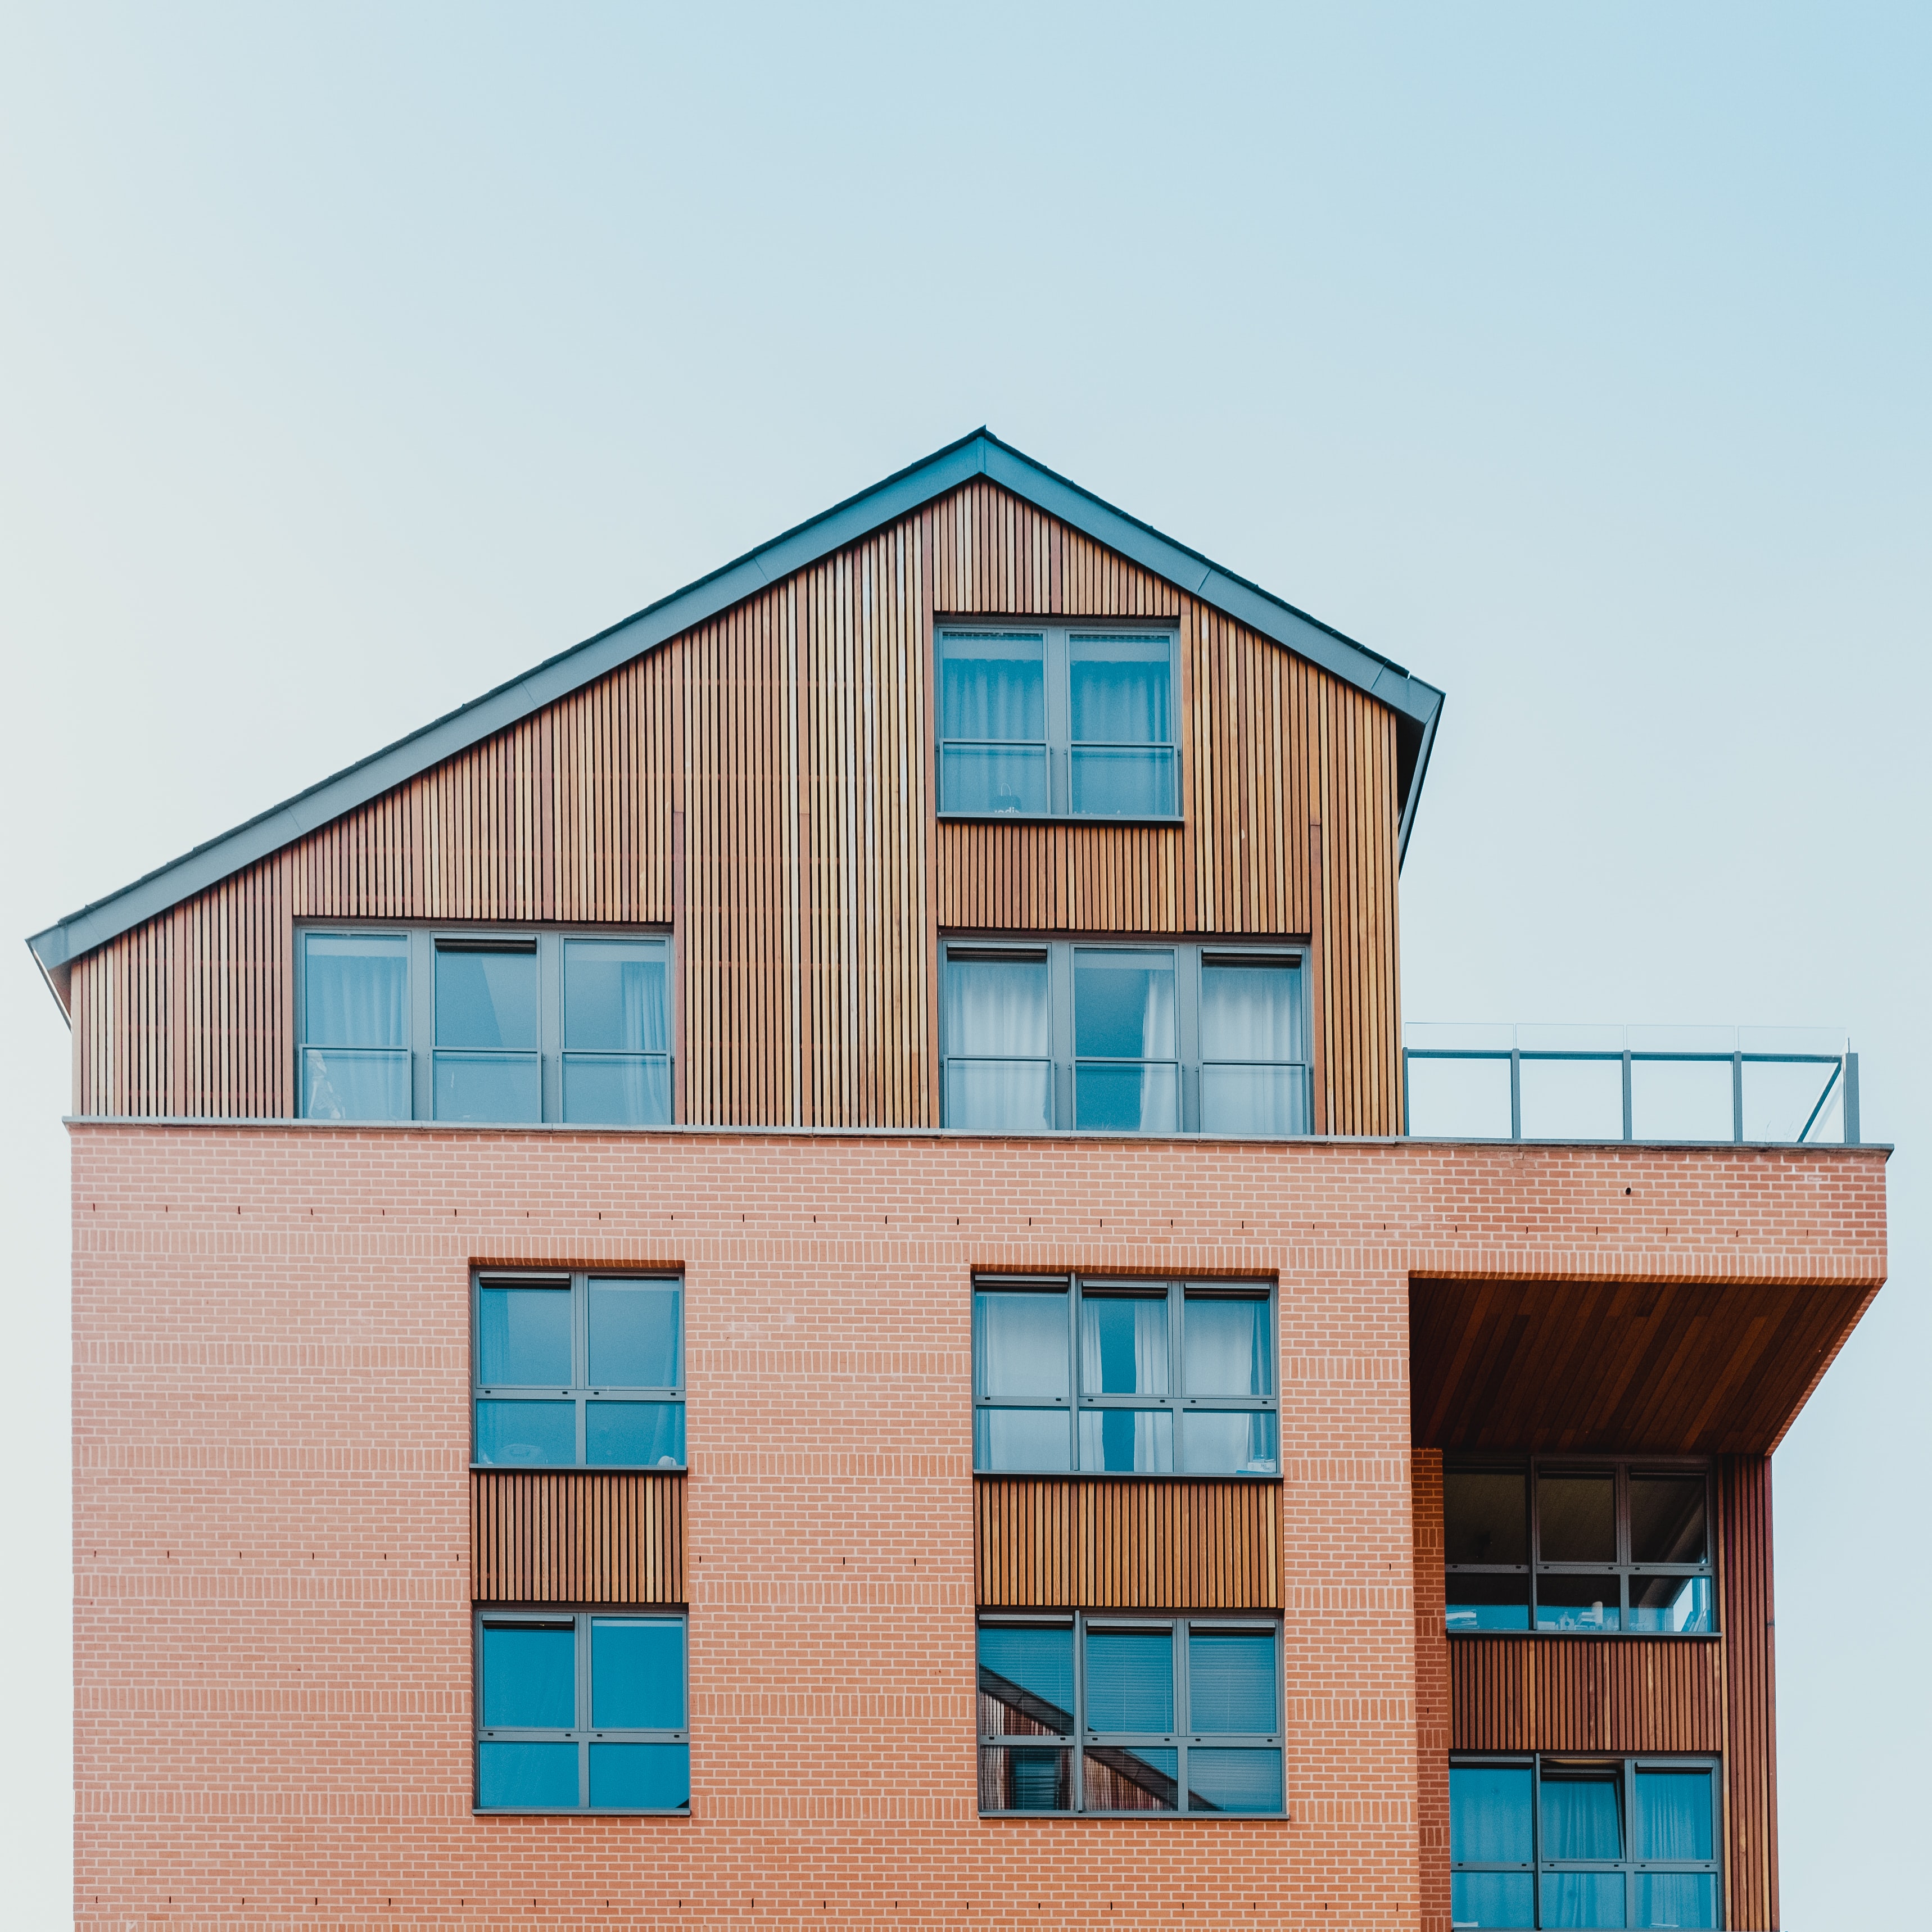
[1409, 1279, 1878, 1455]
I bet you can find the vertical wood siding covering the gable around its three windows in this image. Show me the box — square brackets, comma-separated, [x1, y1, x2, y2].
[71, 481, 1401, 1134]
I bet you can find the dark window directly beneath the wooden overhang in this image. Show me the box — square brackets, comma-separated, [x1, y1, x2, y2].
[1443, 1456, 1717, 1636]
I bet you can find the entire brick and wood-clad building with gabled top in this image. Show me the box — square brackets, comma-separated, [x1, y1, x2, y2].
[31, 433, 1886, 1932]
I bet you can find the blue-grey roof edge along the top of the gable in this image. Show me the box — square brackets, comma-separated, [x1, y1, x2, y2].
[27, 429, 1443, 1005]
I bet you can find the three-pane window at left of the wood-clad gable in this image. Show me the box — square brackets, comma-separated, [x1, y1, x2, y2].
[296, 927, 671, 1126]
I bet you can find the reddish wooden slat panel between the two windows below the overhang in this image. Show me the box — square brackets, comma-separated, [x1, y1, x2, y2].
[1449, 1636, 1723, 1752]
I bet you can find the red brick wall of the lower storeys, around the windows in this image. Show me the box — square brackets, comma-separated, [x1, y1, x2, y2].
[74, 1124, 1884, 1926]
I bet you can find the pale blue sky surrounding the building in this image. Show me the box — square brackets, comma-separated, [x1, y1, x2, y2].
[0, 0, 1932, 1932]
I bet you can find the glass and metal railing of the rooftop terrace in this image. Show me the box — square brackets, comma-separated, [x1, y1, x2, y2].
[1402, 1020, 1858, 1148]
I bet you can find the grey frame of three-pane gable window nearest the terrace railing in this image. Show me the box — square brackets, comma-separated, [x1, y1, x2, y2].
[939, 933, 1314, 1140]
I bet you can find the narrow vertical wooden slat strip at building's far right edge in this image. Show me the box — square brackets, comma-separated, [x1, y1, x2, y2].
[1717, 1455, 1777, 1932]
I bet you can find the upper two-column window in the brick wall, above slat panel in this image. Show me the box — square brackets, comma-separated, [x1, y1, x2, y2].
[469, 1273, 684, 1468]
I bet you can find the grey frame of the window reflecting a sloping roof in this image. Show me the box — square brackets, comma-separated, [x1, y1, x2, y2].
[974, 1609, 1288, 1820]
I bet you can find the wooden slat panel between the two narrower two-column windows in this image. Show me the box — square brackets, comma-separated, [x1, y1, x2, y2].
[469, 1468, 686, 1604]
